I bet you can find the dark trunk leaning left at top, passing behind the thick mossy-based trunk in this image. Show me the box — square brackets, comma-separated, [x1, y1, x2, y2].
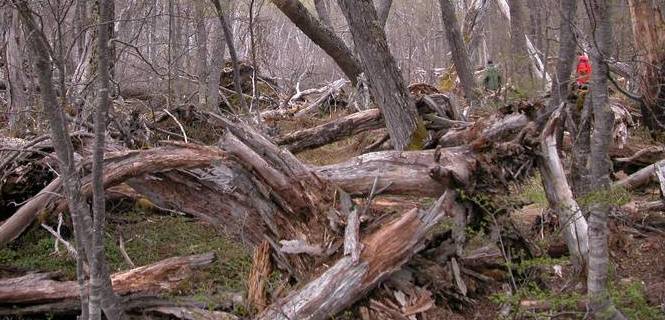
[272, 0, 363, 85]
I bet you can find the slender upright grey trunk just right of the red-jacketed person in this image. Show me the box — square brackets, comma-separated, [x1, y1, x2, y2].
[587, 0, 625, 319]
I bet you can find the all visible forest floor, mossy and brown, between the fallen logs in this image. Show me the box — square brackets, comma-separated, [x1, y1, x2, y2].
[0, 106, 665, 319]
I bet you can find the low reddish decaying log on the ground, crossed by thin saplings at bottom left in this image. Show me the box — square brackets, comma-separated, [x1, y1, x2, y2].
[0, 253, 215, 304]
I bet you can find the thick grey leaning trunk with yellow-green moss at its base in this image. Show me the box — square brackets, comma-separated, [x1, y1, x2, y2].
[338, 0, 427, 150]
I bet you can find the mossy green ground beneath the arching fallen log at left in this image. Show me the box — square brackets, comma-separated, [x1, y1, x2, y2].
[0, 211, 252, 300]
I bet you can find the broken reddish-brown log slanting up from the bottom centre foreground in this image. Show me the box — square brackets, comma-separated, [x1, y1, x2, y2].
[257, 197, 444, 320]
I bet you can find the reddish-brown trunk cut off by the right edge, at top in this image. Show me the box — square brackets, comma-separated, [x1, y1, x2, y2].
[628, 0, 665, 133]
